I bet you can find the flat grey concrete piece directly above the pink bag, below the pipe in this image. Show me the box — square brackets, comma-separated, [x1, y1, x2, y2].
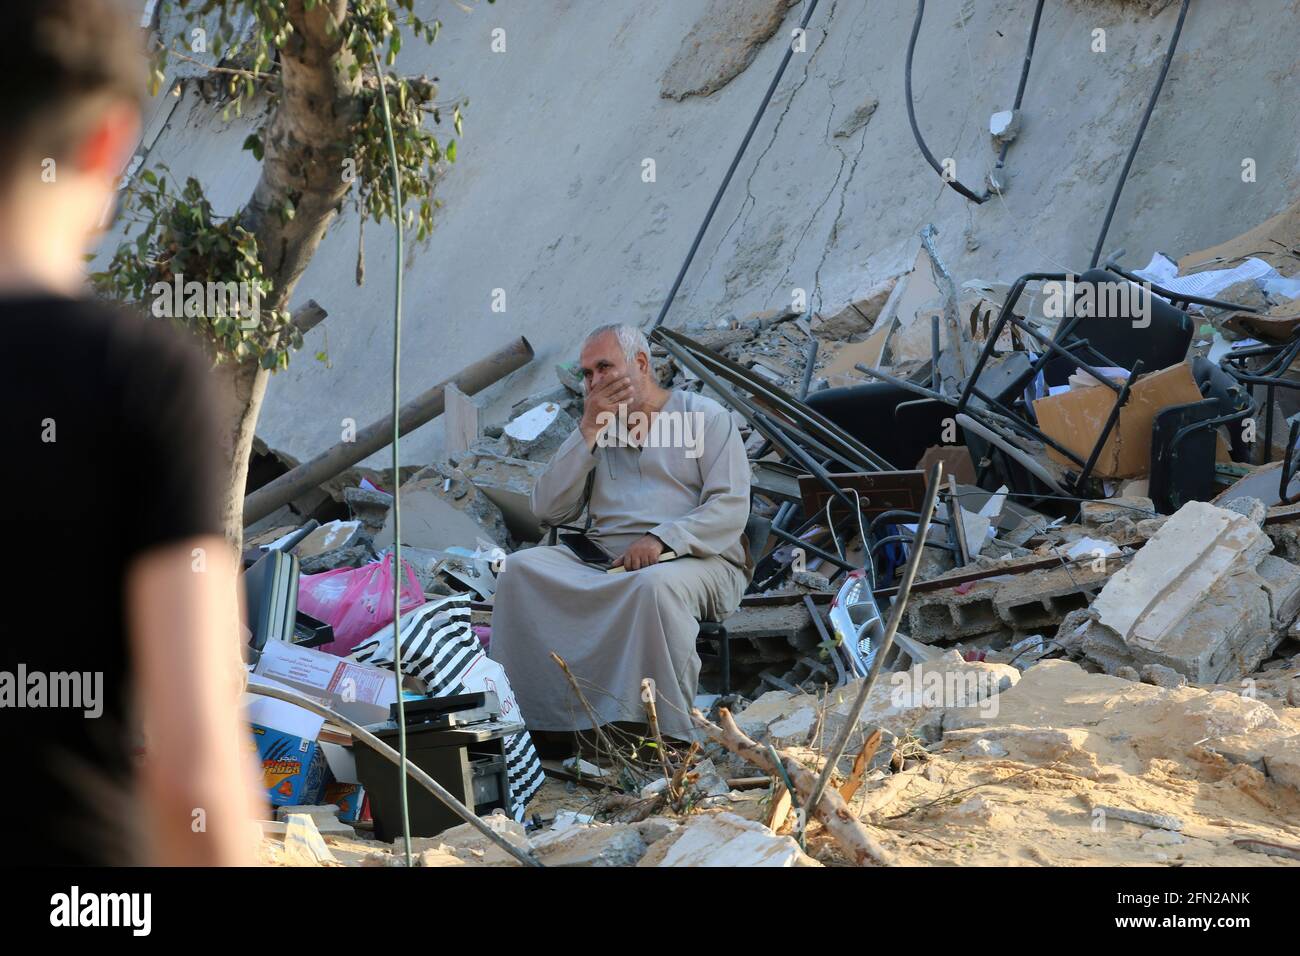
[374, 464, 511, 550]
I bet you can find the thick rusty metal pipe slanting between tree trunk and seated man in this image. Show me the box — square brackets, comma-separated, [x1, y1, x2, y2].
[243, 336, 533, 527]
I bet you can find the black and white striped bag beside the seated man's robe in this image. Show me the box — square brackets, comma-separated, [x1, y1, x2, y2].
[351, 596, 542, 821]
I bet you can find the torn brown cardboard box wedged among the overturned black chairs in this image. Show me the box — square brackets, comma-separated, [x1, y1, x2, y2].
[1034, 362, 1201, 479]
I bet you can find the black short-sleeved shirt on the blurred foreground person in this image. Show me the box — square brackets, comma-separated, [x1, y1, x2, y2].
[0, 297, 225, 864]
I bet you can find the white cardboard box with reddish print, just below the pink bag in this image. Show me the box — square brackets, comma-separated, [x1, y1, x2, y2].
[254, 641, 397, 724]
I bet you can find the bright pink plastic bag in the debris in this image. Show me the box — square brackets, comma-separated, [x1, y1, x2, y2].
[298, 558, 424, 657]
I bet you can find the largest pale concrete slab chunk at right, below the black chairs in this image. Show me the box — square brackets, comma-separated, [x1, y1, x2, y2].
[1082, 502, 1300, 684]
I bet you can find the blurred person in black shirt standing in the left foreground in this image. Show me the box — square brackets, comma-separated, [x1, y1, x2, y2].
[0, 0, 257, 865]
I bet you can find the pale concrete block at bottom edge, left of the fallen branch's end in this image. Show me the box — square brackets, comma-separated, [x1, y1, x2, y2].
[637, 812, 820, 866]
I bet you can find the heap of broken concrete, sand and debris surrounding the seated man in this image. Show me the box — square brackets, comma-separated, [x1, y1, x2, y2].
[247, 200, 1300, 866]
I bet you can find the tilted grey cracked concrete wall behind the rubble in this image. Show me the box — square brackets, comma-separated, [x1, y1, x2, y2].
[96, 0, 1300, 464]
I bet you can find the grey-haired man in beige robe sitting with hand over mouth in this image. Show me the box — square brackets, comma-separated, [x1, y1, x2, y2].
[491, 325, 753, 737]
